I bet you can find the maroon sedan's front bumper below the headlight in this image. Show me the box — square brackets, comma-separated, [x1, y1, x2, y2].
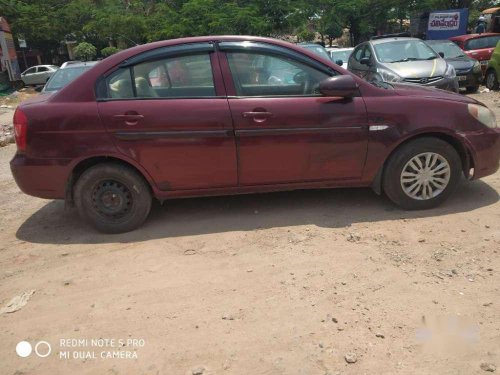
[461, 128, 500, 179]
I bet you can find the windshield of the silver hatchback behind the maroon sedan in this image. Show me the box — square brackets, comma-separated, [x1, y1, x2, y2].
[374, 40, 438, 63]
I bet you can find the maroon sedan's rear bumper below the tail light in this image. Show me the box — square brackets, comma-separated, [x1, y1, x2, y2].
[10, 154, 69, 199]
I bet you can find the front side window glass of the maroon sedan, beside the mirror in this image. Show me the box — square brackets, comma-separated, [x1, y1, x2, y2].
[227, 52, 329, 96]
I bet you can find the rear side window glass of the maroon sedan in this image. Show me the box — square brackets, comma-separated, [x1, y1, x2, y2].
[106, 53, 215, 99]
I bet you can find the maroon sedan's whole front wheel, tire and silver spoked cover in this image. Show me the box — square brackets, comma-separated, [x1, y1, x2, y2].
[383, 137, 462, 210]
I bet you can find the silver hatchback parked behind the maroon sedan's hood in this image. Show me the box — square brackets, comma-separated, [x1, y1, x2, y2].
[348, 37, 458, 92]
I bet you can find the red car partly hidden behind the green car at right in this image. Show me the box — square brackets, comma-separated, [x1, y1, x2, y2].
[450, 33, 500, 73]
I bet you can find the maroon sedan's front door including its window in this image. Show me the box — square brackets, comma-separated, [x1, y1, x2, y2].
[219, 42, 367, 185]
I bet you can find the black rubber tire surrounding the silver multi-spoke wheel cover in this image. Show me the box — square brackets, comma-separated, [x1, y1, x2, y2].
[383, 137, 462, 210]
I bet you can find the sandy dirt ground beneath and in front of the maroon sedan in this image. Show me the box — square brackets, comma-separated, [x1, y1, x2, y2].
[0, 93, 500, 375]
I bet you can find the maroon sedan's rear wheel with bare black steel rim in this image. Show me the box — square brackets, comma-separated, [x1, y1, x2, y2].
[73, 163, 152, 233]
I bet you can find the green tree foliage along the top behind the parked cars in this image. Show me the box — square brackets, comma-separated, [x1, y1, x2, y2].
[0, 0, 496, 59]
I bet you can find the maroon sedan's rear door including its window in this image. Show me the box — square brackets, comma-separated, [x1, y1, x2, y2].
[98, 43, 237, 191]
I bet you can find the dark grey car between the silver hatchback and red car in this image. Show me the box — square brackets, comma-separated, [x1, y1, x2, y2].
[426, 40, 483, 93]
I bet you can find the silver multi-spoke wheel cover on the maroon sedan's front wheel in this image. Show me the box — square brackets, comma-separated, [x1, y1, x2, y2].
[400, 152, 451, 200]
